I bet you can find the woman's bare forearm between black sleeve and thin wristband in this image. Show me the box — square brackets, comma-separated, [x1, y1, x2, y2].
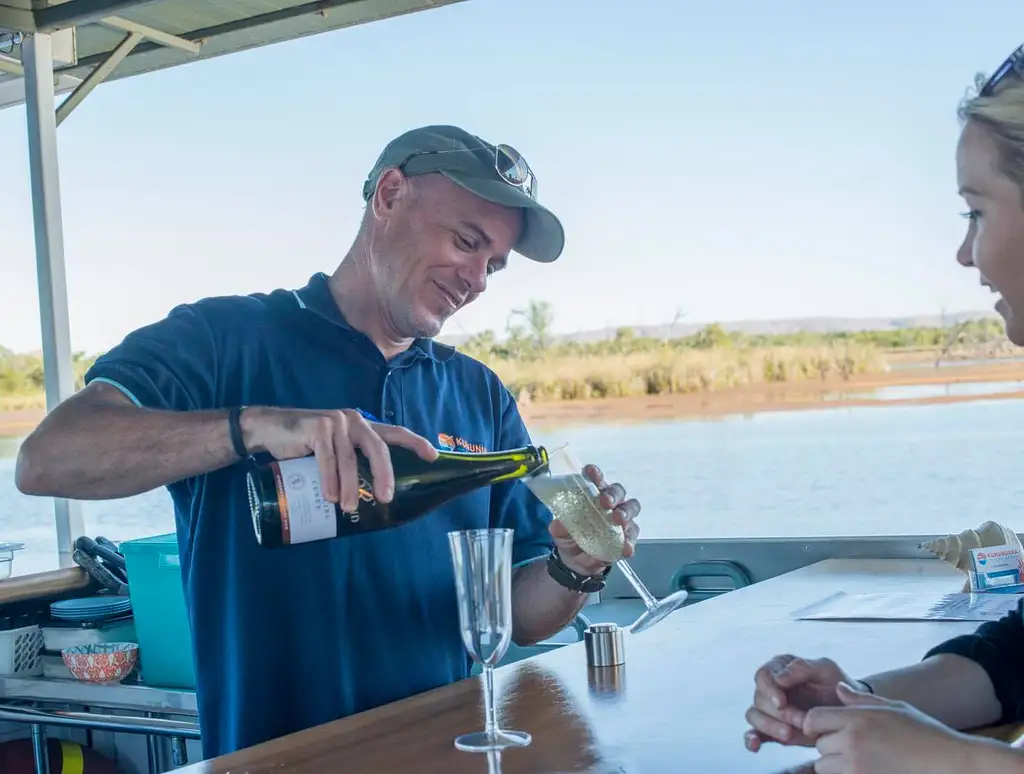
[864, 653, 1002, 729]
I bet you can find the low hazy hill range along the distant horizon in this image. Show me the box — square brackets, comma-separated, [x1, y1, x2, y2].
[438, 310, 999, 346]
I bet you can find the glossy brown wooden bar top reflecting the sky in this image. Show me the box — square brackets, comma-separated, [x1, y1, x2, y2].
[177, 560, 999, 774]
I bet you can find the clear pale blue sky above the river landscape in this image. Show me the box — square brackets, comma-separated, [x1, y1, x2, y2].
[0, 0, 1024, 351]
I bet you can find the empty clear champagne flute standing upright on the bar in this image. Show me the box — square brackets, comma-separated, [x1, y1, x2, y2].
[449, 529, 531, 753]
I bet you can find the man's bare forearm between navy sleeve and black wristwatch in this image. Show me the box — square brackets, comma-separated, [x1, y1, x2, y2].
[512, 559, 587, 645]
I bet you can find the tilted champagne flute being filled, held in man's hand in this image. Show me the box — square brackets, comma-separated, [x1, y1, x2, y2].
[523, 444, 689, 632]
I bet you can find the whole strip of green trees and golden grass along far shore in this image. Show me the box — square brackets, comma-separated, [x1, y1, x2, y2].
[0, 311, 1012, 412]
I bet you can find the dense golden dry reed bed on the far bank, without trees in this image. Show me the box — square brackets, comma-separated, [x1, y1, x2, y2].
[486, 345, 887, 400]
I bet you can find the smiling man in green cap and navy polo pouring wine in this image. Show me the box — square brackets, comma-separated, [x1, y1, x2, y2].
[16, 126, 640, 757]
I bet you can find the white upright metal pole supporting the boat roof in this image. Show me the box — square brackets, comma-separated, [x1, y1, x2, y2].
[22, 33, 85, 566]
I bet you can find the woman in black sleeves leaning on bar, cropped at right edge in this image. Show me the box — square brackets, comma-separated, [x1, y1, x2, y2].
[744, 46, 1024, 774]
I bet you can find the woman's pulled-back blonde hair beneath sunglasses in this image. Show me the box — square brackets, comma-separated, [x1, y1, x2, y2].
[956, 75, 1024, 197]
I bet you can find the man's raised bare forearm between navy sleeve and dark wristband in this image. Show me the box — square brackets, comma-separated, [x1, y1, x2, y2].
[15, 384, 238, 500]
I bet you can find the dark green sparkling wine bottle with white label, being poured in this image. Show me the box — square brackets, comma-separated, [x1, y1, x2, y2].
[246, 445, 548, 548]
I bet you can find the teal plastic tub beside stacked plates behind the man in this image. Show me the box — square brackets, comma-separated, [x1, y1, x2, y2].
[119, 532, 196, 689]
